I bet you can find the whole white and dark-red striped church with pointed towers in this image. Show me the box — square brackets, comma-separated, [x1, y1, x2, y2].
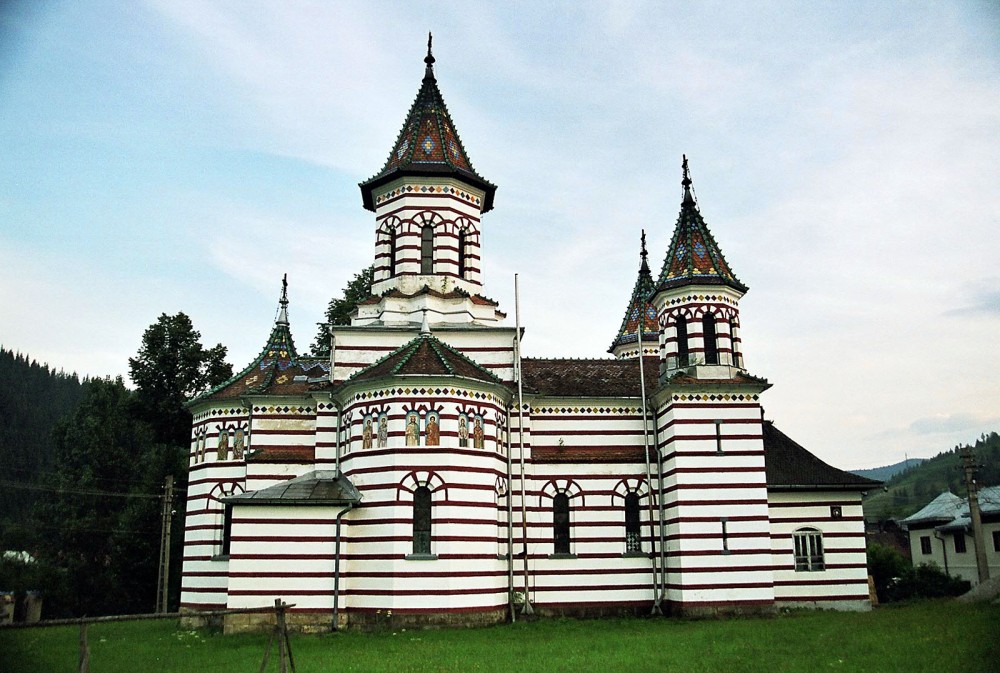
[181, 45, 878, 631]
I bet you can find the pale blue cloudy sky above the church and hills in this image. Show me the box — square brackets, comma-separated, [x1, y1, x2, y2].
[0, 0, 1000, 468]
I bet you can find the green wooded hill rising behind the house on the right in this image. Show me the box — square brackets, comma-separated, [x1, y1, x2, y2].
[864, 432, 1000, 521]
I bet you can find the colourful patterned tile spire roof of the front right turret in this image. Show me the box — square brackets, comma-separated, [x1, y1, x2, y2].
[656, 156, 747, 292]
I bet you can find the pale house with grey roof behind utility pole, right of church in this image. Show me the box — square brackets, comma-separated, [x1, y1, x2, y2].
[900, 486, 1000, 586]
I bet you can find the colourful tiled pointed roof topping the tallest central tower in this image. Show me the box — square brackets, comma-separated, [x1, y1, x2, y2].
[359, 36, 496, 213]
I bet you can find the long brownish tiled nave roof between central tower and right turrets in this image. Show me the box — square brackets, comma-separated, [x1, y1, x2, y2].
[521, 357, 660, 397]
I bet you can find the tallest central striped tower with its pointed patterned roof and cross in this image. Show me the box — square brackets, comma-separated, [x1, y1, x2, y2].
[352, 35, 504, 326]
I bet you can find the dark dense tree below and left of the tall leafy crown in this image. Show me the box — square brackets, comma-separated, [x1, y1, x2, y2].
[27, 378, 168, 616]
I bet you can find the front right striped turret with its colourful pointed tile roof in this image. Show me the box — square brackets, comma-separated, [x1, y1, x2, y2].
[650, 156, 747, 379]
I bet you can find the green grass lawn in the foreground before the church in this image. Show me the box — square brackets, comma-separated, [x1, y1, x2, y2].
[0, 601, 1000, 673]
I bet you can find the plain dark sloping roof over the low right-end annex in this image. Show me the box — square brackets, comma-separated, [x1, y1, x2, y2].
[764, 421, 882, 491]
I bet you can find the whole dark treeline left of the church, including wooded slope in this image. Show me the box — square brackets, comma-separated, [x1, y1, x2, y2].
[0, 313, 232, 618]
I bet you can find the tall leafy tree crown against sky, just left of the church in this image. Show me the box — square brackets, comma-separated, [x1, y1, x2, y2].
[128, 313, 233, 447]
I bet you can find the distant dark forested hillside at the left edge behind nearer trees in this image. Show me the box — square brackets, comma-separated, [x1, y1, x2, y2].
[0, 347, 87, 549]
